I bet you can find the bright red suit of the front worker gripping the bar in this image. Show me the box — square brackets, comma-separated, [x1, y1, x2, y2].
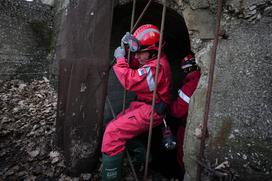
[101, 55, 172, 156]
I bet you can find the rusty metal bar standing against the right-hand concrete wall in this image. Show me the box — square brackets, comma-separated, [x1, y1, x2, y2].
[196, 0, 223, 181]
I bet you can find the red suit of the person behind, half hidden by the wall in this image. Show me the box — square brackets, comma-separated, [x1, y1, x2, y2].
[170, 57, 201, 173]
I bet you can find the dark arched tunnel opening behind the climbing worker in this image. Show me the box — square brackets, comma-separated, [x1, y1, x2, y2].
[104, 1, 191, 177]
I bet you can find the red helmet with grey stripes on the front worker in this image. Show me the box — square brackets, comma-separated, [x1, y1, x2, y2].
[133, 24, 160, 51]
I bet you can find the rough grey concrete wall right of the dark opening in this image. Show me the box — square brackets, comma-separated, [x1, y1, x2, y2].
[181, 0, 272, 180]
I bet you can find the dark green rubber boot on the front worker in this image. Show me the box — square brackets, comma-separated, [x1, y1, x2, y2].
[102, 152, 124, 181]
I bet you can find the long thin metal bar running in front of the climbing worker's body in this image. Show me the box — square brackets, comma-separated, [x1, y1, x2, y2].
[144, 0, 166, 181]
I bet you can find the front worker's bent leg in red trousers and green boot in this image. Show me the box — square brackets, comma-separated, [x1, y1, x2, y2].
[101, 103, 161, 180]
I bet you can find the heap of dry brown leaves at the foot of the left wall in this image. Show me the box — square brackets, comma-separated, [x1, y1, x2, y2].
[0, 78, 64, 180]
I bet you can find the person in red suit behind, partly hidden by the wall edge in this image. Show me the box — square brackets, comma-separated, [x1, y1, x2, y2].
[169, 52, 201, 177]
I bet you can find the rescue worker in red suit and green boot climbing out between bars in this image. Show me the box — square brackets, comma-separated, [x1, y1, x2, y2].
[101, 24, 171, 180]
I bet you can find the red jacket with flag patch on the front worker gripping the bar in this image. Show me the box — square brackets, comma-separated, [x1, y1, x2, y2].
[113, 54, 172, 104]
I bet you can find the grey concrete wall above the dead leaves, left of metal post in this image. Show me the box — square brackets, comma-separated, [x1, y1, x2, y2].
[0, 0, 54, 80]
